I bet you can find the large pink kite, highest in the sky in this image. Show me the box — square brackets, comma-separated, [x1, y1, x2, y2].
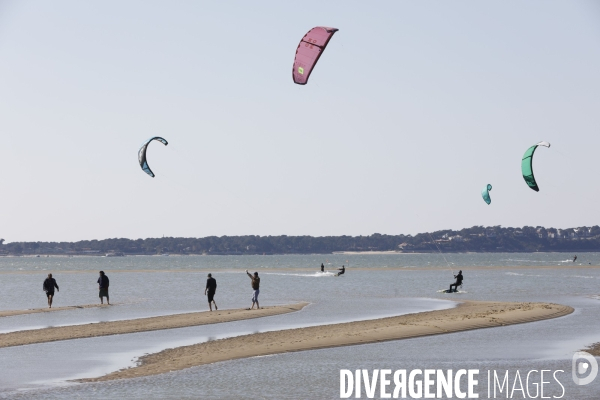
[292, 26, 339, 85]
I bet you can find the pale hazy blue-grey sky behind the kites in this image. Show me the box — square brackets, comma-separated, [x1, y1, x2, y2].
[0, 0, 600, 242]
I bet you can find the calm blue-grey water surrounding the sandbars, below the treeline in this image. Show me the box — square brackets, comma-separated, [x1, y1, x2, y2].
[0, 253, 600, 399]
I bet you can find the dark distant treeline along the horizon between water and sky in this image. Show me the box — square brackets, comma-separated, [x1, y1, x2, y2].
[0, 226, 600, 255]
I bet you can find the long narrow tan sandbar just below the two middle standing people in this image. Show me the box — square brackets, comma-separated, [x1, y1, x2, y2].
[0, 303, 308, 348]
